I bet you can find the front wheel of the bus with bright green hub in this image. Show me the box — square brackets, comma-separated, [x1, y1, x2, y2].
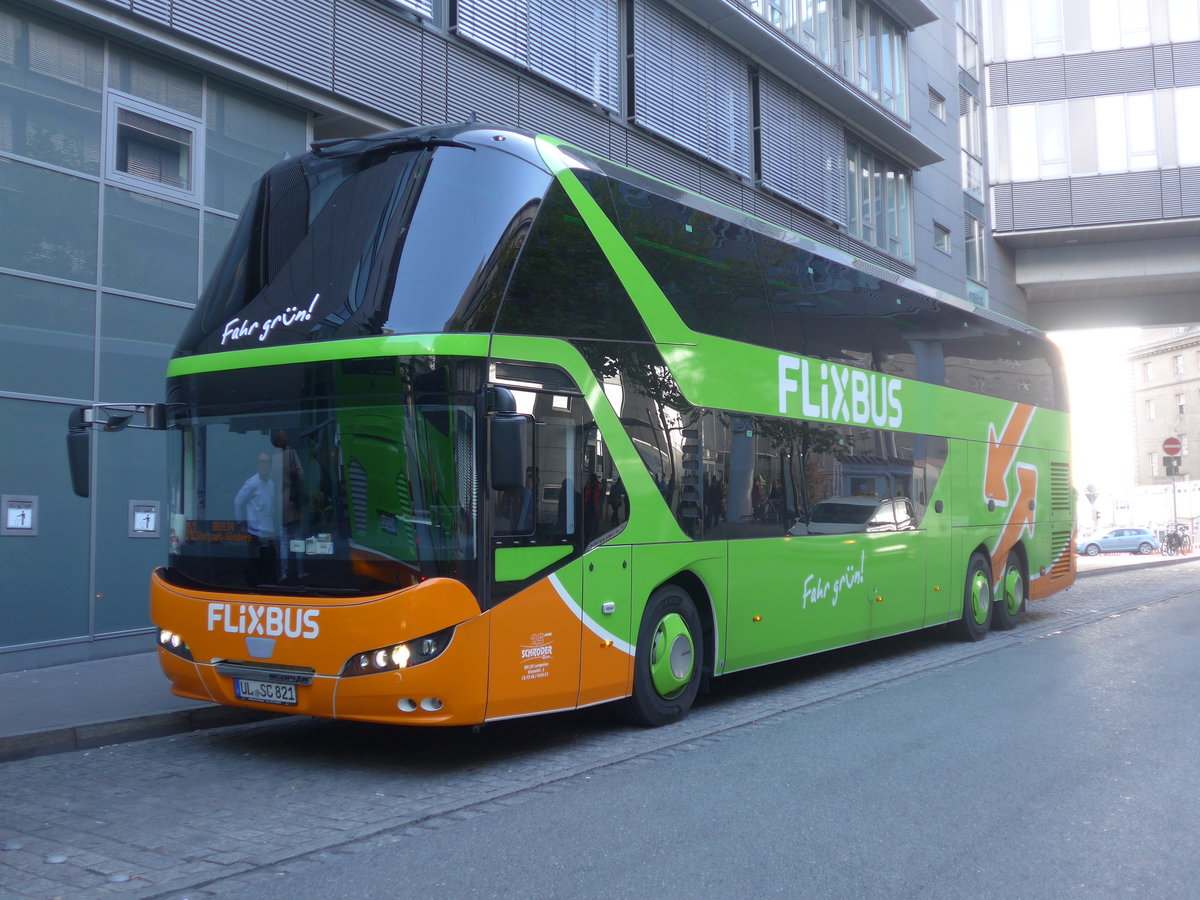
[625, 584, 704, 727]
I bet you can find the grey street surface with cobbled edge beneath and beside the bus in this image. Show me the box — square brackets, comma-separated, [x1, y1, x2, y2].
[0, 560, 1200, 900]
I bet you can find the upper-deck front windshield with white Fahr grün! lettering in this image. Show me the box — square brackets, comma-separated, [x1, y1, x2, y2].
[180, 144, 550, 353]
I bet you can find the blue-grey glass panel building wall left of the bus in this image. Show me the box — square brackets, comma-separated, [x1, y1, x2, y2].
[0, 6, 310, 667]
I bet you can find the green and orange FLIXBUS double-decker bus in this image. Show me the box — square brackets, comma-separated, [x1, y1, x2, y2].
[71, 124, 1075, 725]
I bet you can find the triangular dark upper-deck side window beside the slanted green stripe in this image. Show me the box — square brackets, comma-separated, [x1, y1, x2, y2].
[496, 173, 650, 341]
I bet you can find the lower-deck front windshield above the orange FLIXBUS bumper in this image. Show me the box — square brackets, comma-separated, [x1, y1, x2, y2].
[169, 358, 478, 594]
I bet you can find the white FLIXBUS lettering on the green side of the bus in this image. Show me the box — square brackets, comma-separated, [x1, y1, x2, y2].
[779, 354, 904, 428]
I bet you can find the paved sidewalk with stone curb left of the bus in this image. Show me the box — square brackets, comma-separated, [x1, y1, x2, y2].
[0, 652, 272, 762]
